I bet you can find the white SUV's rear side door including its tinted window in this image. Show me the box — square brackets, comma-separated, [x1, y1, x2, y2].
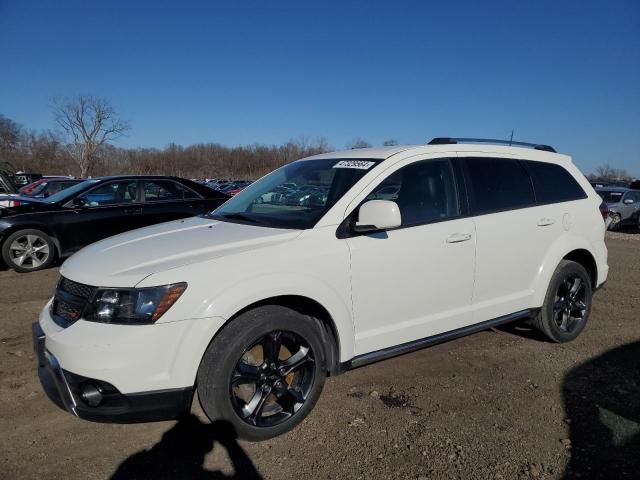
[460, 158, 562, 323]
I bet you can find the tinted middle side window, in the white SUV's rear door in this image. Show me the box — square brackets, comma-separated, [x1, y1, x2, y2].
[467, 158, 535, 213]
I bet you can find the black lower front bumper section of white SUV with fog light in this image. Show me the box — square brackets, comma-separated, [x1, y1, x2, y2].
[32, 322, 193, 423]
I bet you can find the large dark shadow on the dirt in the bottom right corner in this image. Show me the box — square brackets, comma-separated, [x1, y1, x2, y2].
[562, 341, 640, 480]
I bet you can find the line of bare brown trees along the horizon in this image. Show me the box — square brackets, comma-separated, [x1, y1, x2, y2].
[0, 96, 632, 183]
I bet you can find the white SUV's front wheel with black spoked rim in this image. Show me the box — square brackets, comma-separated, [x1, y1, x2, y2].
[197, 305, 327, 441]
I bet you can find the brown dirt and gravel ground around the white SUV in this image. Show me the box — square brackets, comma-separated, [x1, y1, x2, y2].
[0, 234, 640, 480]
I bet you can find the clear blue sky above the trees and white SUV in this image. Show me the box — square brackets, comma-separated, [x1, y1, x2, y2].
[0, 0, 640, 176]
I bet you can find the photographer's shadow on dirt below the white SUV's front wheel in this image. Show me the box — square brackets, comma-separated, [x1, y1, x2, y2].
[111, 415, 262, 480]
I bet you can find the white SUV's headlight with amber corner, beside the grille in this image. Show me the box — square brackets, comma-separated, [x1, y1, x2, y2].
[82, 283, 187, 325]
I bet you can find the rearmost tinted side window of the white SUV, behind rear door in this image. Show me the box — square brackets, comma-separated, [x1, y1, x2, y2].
[524, 160, 587, 203]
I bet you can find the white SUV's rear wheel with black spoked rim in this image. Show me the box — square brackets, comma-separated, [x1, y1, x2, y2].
[533, 260, 593, 343]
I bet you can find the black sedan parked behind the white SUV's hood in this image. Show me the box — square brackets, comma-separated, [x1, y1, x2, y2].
[0, 176, 229, 272]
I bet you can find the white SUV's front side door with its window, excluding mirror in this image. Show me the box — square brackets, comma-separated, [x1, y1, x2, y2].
[346, 158, 475, 355]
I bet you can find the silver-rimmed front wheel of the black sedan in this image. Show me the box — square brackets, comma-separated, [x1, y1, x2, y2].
[2, 229, 56, 273]
